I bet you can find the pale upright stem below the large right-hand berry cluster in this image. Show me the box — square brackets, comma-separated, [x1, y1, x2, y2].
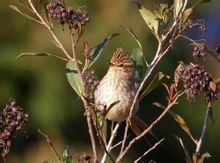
[195, 106, 211, 154]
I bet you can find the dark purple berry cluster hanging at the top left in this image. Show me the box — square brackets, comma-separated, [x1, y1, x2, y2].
[46, 2, 90, 29]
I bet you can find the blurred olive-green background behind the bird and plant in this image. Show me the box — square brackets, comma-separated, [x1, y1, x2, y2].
[0, 0, 220, 163]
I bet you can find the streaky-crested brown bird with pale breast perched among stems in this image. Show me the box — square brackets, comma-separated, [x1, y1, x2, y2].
[94, 48, 150, 134]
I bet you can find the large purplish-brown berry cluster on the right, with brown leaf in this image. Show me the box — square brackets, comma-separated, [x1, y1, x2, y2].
[175, 63, 217, 103]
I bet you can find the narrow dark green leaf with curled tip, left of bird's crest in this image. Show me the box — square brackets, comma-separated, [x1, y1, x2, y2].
[83, 33, 119, 71]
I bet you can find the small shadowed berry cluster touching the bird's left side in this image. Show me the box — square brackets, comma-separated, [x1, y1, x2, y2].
[83, 70, 99, 101]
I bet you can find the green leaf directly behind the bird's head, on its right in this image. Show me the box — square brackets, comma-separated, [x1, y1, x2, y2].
[131, 48, 146, 83]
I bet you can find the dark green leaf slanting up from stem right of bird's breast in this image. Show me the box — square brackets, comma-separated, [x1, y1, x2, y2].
[140, 72, 167, 99]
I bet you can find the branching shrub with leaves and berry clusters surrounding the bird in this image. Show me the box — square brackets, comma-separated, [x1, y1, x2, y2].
[2, 0, 219, 163]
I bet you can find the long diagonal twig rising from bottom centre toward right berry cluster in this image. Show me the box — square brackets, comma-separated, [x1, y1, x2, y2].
[116, 91, 186, 162]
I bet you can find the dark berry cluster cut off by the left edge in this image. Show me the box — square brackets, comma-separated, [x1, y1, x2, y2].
[0, 99, 28, 157]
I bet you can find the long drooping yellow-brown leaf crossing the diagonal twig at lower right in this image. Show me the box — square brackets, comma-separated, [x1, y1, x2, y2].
[152, 102, 198, 144]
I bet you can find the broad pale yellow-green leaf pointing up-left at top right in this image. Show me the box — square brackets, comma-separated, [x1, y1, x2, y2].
[135, 2, 159, 39]
